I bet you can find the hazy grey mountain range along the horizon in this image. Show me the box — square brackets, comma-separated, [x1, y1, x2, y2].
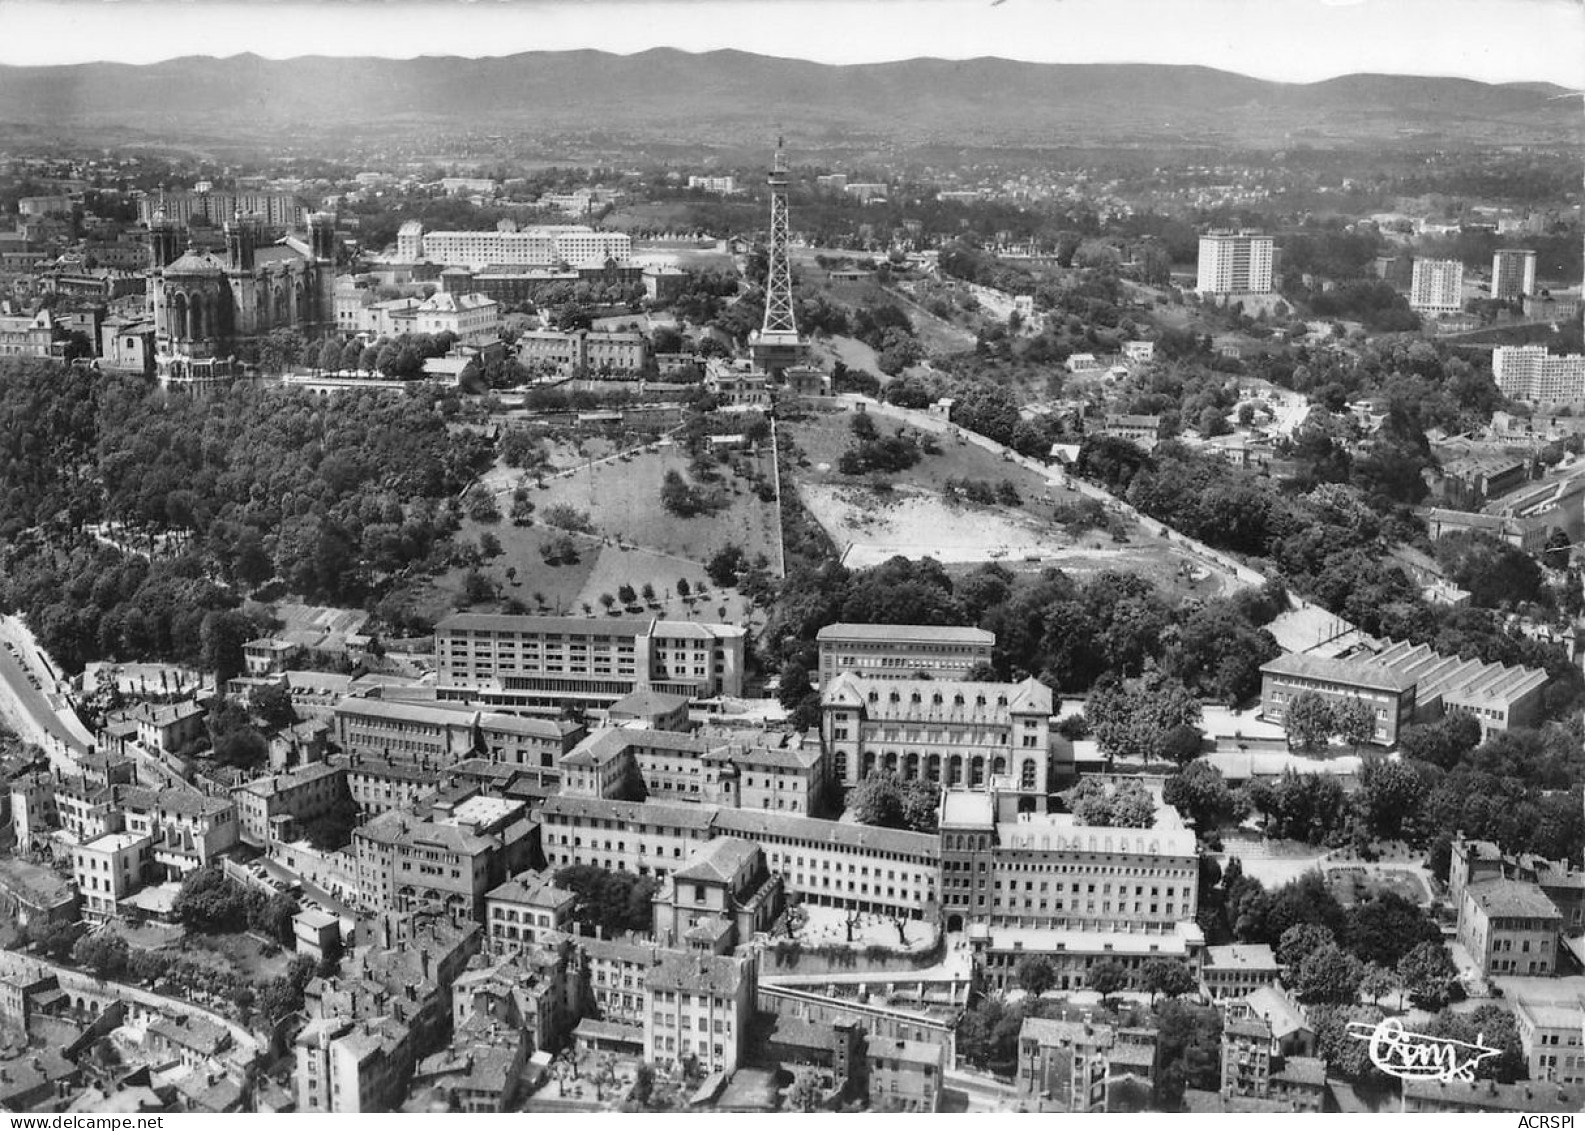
[0, 49, 1585, 147]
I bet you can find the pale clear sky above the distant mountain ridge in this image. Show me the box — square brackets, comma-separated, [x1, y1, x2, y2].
[0, 0, 1585, 90]
